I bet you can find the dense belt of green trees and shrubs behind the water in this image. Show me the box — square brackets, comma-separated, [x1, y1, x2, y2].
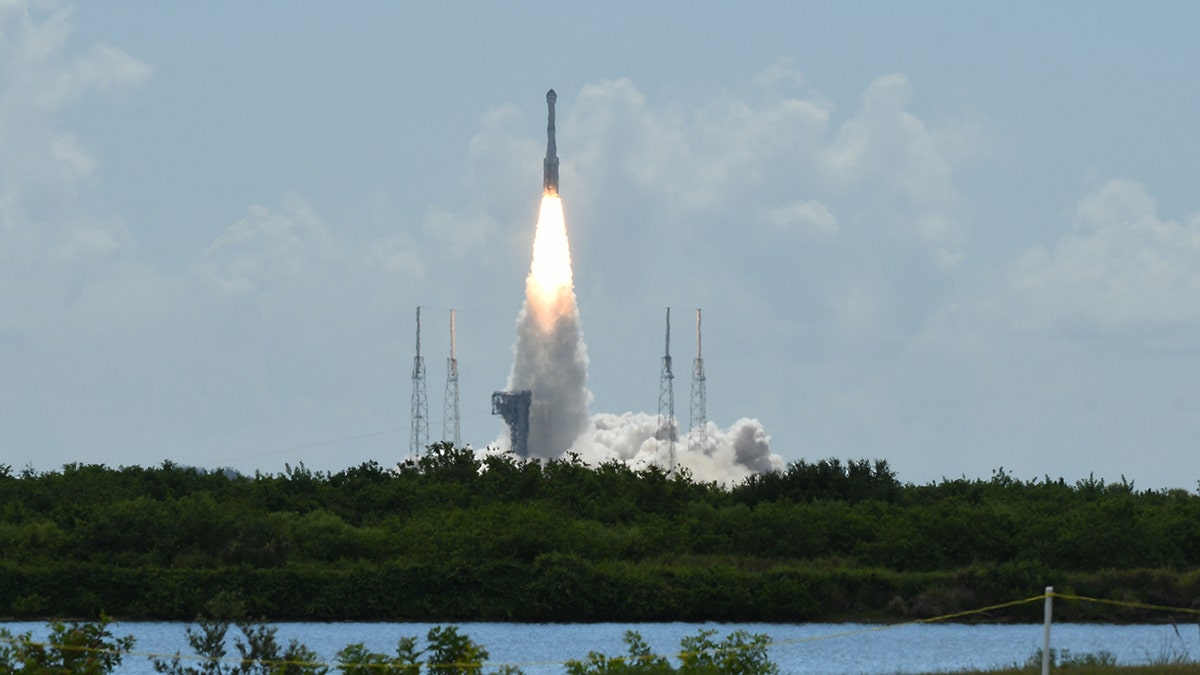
[0, 444, 1200, 622]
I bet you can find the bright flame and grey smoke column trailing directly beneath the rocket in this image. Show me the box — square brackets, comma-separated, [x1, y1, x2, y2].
[508, 189, 592, 458]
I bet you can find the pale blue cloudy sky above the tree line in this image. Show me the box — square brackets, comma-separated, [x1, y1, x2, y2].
[0, 0, 1200, 482]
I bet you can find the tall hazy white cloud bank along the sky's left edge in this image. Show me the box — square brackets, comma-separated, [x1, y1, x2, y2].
[0, 2, 163, 340]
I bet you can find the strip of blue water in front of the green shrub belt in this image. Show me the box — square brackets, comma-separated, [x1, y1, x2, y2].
[0, 622, 1200, 675]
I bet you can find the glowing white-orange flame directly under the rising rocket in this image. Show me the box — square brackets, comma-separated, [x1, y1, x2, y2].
[526, 191, 575, 333]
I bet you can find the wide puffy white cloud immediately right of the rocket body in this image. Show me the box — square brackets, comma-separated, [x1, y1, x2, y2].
[535, 67, 984, 276]
